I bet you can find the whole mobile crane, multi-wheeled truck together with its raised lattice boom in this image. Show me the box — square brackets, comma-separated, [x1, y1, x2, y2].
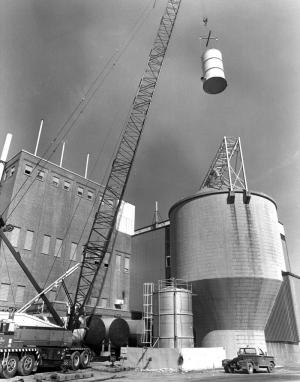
[0, 0, 181, 378]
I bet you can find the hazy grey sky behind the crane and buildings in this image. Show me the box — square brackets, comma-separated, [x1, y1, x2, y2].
[0, 0, 300, 274]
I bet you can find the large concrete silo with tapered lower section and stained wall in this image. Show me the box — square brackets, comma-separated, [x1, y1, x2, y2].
[169, 191, 284, 357]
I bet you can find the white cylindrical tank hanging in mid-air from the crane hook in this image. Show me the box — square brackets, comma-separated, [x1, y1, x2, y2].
[202, 49, 227, 94]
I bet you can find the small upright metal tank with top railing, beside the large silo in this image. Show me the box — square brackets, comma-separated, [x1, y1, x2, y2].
[153, 280, 194, 348]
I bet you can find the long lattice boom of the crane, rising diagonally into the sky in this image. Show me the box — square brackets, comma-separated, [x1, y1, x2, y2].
[69, 0, 181, 328]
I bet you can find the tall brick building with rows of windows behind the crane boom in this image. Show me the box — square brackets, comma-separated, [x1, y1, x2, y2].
[0, 150, 134, 316]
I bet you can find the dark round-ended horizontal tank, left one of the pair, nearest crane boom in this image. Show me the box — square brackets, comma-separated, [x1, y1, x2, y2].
[84, 315, 106, 353]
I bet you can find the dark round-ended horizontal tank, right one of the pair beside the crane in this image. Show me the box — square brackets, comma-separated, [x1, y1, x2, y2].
[102, 317, 129, 348]
